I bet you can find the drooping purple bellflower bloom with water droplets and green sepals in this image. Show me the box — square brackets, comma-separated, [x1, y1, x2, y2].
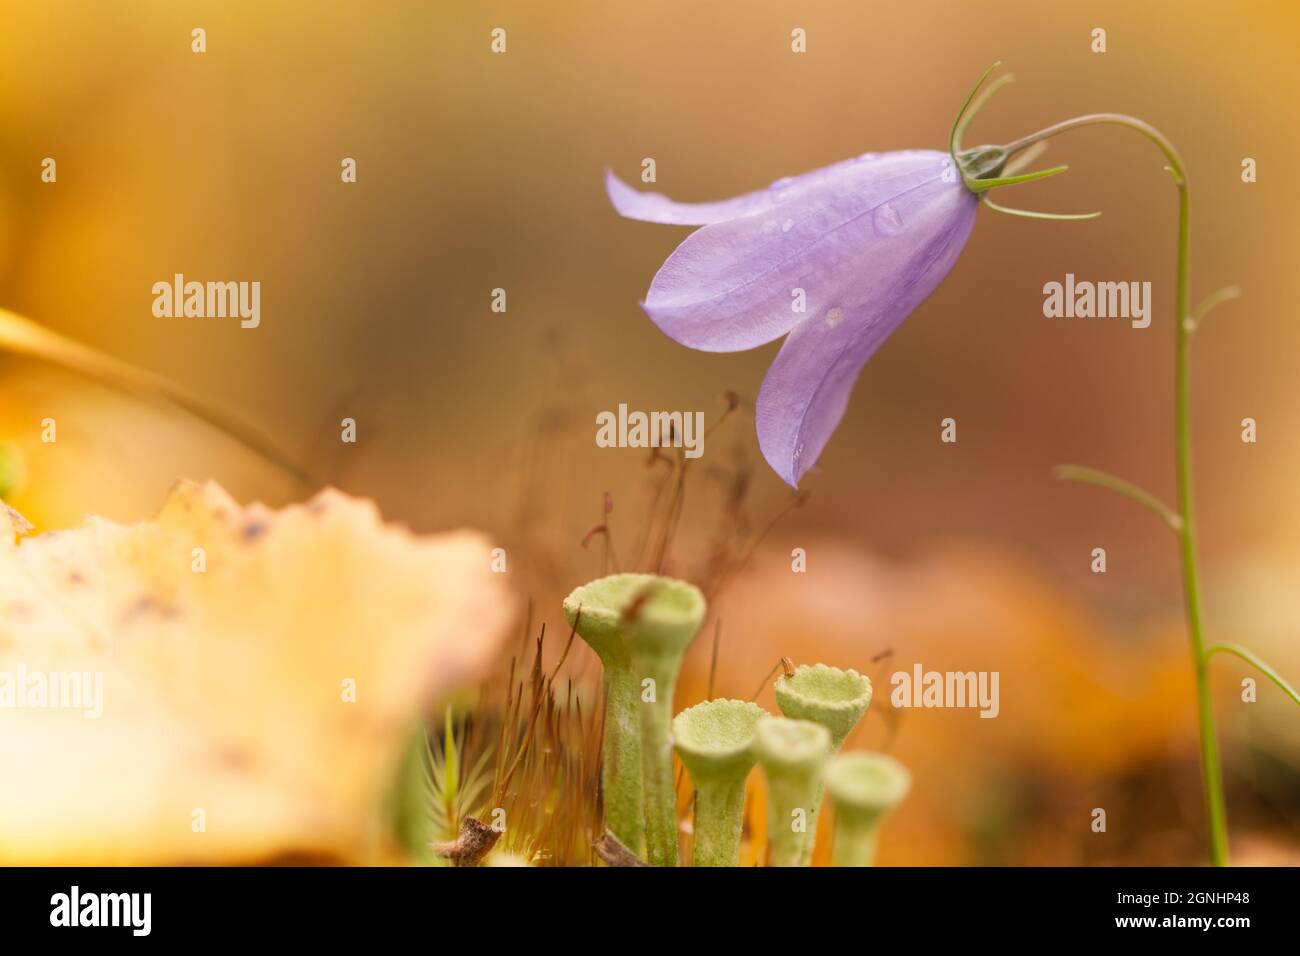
[606, 65, 1092, 486]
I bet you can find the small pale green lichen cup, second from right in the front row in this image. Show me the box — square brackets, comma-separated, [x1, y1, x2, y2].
[754, 717, 831, 866]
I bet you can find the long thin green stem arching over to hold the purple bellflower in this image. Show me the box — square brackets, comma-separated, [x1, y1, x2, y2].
[1005, 113, 1227, 866]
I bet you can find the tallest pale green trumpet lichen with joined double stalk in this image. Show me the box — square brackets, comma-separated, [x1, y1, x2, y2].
[564, 574, 707, 866]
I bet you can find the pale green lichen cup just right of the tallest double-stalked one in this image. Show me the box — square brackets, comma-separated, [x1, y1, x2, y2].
[672, 700, 767, 866]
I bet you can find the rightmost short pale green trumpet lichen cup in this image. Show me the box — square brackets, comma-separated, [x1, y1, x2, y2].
[826, 753, 911, 866]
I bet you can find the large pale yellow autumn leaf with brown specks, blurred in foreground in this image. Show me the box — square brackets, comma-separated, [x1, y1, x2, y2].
[0, 483, 512, 864]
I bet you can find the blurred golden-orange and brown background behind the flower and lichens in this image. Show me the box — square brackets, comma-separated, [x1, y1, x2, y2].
[0, 0, 1300, 864]
